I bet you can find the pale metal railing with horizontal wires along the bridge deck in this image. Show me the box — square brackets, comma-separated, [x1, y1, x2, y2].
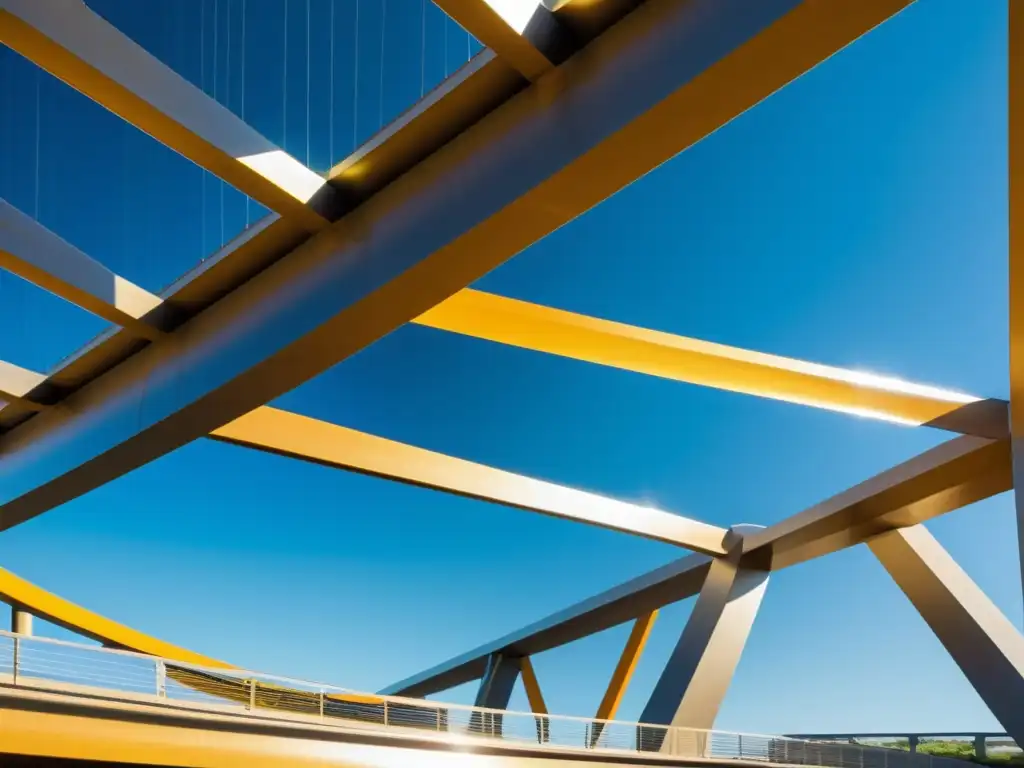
[0, 632, 965, 768]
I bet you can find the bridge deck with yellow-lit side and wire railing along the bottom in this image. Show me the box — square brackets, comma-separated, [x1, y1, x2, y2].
[0, 633, 964, 768]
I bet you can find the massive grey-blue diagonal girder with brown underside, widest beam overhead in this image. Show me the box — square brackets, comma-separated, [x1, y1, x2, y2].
[0, 0, 907, 527]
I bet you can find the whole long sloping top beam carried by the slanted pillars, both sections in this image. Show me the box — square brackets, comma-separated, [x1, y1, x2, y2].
[382, 437, 1012, 696]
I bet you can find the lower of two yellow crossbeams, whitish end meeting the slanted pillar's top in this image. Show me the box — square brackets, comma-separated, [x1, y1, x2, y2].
[210, 407, 726, 555]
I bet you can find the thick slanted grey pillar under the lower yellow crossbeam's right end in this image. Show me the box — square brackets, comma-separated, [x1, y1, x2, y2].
[639, 526, 769, 757]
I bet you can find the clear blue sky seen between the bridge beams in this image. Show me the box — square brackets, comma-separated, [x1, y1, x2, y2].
[0, 0, 1022, 733]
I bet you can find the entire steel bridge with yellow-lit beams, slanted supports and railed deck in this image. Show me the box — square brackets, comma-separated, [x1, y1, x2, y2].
[0, 0, 1024, 768]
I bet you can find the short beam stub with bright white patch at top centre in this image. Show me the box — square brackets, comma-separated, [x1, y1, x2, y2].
[434, 0, 564, 81]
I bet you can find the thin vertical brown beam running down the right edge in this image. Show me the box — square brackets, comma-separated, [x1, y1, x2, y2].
[1007, 0, 1024, 622]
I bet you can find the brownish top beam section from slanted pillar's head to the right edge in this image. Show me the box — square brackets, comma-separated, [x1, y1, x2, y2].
[743, 436, 1013, 569]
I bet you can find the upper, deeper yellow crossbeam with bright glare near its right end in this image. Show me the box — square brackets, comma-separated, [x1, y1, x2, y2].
[414, 289, 978, 425]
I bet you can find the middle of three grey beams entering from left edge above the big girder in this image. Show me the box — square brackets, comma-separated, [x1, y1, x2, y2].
[0, 200, 161, 340]
